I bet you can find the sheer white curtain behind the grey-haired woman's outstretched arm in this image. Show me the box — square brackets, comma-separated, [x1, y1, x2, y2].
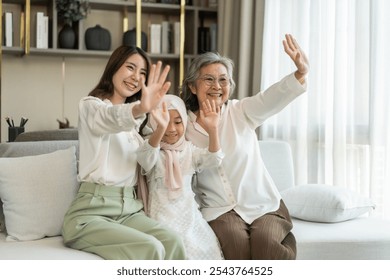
[260, 0, 390, 219]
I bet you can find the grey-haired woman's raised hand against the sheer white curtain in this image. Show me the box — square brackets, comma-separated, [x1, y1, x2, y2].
[283, 34, 309, 80]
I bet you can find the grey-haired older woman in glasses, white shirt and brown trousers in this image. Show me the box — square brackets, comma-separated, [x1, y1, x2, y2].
[182, 35, 309, 259]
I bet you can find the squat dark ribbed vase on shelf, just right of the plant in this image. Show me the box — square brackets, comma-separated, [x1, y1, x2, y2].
[84, 24, 111, 51]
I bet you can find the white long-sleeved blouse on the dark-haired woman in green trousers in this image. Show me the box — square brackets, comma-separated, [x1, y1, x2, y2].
[78, 96, 146, 187]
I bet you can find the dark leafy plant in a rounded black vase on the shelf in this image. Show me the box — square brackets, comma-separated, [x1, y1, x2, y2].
[56, 0, 90, 49]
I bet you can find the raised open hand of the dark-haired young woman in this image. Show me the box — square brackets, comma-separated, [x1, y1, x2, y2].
[139, 61, 171, 114]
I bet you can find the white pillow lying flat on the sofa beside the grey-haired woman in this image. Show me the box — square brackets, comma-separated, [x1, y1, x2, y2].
[281, 184, 375, 223]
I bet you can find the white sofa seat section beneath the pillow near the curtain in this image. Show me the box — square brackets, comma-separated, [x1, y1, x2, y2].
[292, 217, 390, 260]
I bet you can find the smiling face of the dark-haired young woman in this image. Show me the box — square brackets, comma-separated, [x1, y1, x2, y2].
[110, 54, 147, 104]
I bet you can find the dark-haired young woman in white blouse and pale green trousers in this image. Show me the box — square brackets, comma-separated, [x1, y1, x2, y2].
[63, 46, 185, 260]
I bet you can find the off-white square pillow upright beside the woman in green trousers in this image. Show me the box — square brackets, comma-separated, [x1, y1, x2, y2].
[0, 146, 79, 241]
